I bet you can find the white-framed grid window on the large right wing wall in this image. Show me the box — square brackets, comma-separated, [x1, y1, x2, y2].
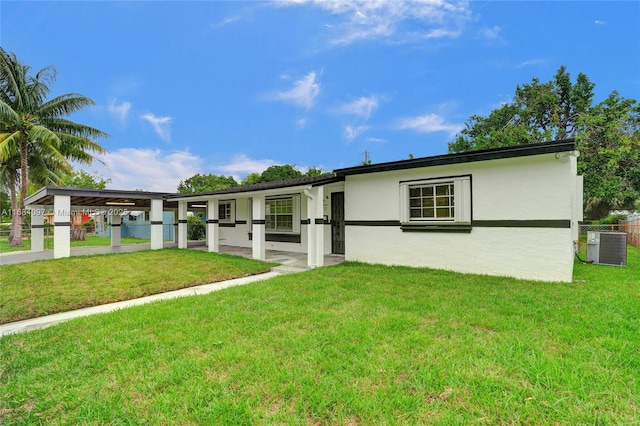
[400, 176, 471, 224]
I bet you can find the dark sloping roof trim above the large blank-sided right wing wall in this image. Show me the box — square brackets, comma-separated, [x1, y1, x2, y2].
[334, 139, 575, 177]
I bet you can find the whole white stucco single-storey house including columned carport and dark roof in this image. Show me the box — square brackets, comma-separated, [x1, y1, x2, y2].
[26, 140, 582, 282]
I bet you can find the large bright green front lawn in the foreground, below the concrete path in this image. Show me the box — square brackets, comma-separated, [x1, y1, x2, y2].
[0, 247, 640, 425]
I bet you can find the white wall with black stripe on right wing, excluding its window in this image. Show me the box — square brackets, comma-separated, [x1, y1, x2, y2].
[345, 154, 577, 281]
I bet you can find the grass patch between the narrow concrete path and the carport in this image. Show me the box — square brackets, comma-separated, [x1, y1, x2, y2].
[0, 249, 274, 323]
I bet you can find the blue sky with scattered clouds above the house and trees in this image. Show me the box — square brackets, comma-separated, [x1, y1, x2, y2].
[0, 0, 640, 192]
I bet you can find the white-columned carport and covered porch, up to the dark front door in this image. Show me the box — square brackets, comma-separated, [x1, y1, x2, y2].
[21, 175, 344, 268]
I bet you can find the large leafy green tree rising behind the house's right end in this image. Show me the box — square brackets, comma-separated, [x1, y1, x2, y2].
[449, 66, 640, 218]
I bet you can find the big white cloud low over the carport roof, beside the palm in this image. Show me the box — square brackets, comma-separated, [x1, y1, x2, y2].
[89, 148, 204, 192]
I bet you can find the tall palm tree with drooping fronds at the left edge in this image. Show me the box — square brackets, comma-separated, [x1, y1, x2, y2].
[0, 47, 108, 246]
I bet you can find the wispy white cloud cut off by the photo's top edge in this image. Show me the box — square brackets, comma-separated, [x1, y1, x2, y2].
[276, 0, 471, 45]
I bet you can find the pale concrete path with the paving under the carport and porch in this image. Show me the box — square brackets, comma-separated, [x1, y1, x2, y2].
[0, 243, 344, 338]
